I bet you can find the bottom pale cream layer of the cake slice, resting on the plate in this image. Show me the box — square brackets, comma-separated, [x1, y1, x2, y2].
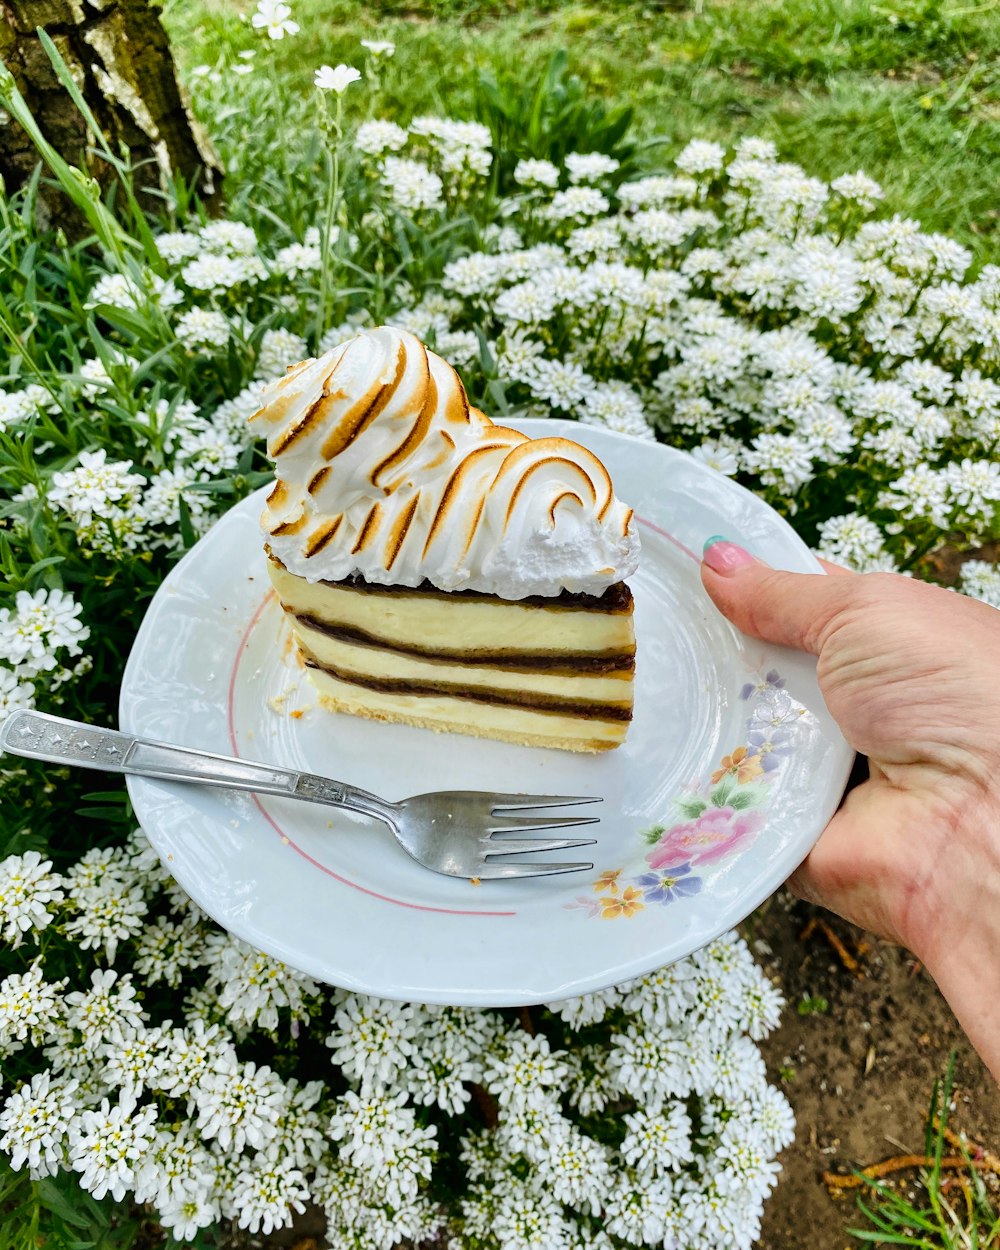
[309, 668, 629, 751]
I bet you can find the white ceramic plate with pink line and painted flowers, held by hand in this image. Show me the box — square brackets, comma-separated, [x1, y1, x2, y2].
[121, 420, 853, 1006]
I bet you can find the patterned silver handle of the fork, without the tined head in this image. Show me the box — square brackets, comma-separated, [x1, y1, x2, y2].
[0, 710, 391, 820]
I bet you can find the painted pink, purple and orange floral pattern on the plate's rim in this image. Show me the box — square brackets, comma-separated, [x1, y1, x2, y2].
[564, 669, 805, 920]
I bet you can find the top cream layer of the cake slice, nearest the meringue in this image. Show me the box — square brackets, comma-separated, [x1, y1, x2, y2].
[268, 559, 635, 666]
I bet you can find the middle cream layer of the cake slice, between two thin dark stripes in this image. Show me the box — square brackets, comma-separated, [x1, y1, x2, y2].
[291, 618, 633, 714]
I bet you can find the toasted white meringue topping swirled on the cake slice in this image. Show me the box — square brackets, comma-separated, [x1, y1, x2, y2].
[250, 326, 639, 599]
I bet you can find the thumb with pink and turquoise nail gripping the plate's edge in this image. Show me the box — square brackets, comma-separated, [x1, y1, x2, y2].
[701, 535, 858, 655]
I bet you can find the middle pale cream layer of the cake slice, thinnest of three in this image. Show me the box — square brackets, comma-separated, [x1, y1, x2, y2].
[291, 619, 633, 708]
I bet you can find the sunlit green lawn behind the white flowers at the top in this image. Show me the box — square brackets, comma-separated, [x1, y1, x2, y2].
[164, 0, 1000, 261]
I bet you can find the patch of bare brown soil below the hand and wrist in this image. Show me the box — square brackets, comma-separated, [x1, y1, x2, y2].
[745, 891, 1000, 1250]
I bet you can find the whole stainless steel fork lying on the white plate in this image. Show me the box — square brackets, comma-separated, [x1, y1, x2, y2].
[0, 711, 601, 881]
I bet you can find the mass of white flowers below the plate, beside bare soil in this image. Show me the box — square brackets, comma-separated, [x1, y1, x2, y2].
[0, 831, 793, 1250]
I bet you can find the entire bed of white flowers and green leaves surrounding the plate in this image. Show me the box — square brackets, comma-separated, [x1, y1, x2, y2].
[0, 36, 1000, 1250]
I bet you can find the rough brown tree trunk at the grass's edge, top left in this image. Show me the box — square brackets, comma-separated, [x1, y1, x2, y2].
[0, 0, 221, 224]
